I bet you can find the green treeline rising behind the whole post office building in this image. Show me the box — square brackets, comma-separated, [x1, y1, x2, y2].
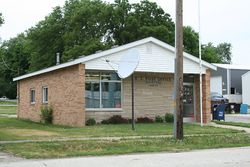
[0, 0, 231, 97]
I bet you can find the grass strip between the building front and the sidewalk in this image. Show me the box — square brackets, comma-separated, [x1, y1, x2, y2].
[0, 117, 242, 141]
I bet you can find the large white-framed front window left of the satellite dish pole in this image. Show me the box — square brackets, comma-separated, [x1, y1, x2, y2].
[85, 73, 121, 109]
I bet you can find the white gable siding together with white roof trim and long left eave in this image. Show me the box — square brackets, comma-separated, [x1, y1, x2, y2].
[13, 37, 213, 81]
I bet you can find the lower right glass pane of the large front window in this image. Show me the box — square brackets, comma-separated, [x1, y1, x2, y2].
[102, 82, 121, 108]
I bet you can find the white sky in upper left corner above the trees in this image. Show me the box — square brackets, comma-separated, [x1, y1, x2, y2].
[0, 0, 64, 40]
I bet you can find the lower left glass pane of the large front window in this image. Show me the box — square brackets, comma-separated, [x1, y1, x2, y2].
[85, 82, 100, 108]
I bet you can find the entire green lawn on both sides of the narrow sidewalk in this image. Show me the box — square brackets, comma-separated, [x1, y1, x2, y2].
[0, 117, 250, 158]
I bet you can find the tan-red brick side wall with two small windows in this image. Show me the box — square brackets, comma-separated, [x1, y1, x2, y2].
[17, 64, 85, 126]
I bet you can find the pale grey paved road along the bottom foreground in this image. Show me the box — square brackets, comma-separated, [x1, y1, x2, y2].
[0, 147, 250, 167]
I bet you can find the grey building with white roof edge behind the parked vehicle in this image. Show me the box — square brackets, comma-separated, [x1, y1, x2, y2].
[210, 64, 250, 104]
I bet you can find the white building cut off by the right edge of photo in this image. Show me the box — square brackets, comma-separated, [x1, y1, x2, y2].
[242, 72, 250, 106]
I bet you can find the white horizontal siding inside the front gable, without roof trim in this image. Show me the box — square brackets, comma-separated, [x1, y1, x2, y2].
[85, 42, 206, 74]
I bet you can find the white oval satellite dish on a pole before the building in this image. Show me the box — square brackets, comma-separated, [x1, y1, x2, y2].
[117, 49, 140, 79]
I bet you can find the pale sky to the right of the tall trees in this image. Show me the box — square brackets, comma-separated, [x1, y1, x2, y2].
[154, 0, 250, 65]
